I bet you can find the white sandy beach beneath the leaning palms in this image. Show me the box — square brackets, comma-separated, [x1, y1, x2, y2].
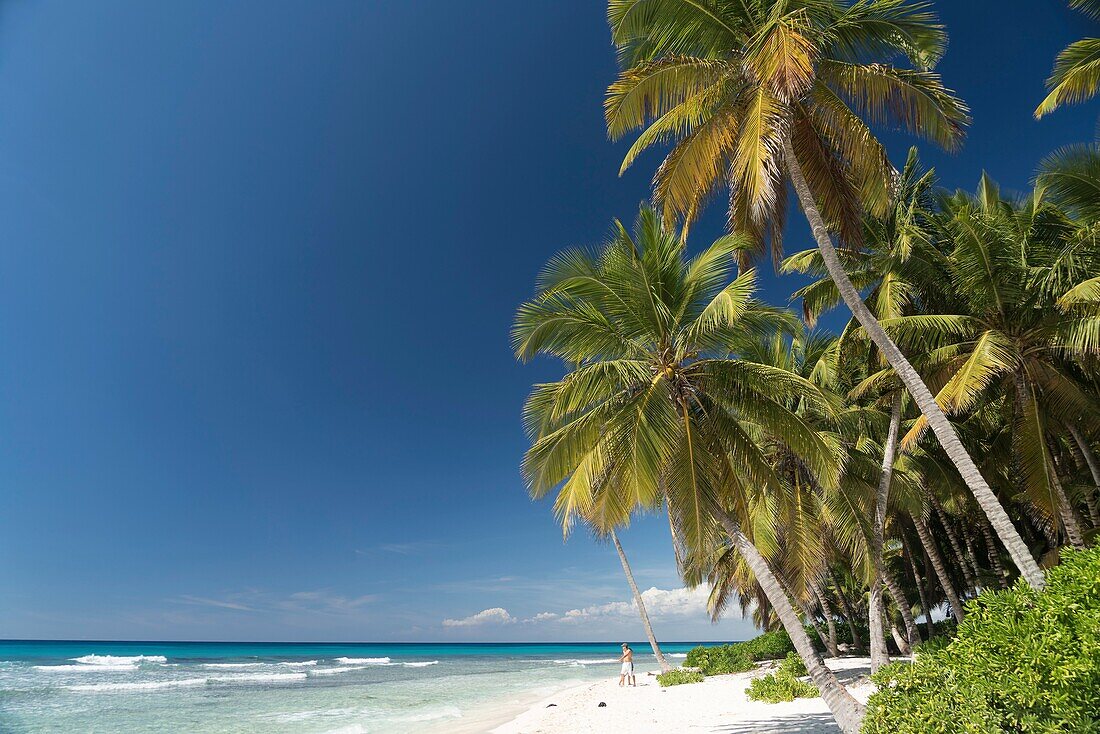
[492, 658, 875, 734]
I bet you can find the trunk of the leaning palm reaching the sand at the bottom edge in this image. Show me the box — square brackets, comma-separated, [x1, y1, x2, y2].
[716, 508, 864, 734]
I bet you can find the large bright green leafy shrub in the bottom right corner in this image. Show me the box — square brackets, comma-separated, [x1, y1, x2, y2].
[864, 547, 1100, 734]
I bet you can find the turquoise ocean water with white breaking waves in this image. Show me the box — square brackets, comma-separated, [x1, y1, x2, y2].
[0, 642, 717, 734]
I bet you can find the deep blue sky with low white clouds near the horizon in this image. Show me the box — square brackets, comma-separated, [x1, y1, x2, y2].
[0, 0, 1100, 640]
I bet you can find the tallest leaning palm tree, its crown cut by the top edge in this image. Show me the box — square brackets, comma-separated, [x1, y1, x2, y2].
[605, 0, 1043, 588]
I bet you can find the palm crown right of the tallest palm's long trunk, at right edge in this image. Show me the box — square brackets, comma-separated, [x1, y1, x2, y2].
[883, 176, 1100, 546]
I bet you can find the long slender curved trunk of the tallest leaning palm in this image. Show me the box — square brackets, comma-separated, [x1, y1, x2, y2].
[783, 135, 1045, 589]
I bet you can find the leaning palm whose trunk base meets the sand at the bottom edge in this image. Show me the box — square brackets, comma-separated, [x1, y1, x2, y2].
[513, 208, 862, 732]
